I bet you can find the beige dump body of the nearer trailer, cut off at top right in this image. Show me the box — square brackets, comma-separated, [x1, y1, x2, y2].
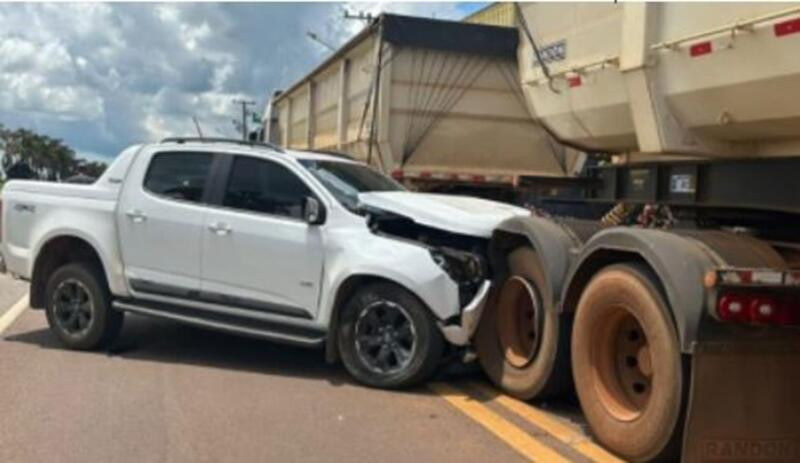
[519, 2, 800, 158]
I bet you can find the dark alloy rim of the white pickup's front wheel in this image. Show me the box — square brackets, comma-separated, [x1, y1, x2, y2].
[355, 301, 417, 374]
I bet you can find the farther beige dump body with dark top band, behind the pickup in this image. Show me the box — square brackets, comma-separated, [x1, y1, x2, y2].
[269, 14, 576, 183]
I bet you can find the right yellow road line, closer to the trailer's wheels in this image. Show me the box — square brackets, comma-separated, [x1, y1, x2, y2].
[469, 382, 624, 463]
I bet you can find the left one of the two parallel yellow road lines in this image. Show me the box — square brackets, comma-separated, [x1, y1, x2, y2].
[428, 383, 569, 463]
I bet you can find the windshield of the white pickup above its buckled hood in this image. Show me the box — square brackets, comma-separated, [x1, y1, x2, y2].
[300, 159, 405, 211]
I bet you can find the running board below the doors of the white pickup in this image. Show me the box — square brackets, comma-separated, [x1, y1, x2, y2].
[112, 300, 326, 347]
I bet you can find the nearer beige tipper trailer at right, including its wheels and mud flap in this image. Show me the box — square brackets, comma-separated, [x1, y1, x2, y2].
[468, 3, 800, 462]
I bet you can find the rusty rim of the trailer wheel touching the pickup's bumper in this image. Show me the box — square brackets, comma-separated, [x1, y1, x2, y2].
[497, 276, 541, 368]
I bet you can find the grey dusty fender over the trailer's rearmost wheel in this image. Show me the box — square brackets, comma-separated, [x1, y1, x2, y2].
[561, 227, 782, 353]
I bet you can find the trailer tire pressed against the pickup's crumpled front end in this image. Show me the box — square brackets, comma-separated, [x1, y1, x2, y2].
[475, 247, 572, 400]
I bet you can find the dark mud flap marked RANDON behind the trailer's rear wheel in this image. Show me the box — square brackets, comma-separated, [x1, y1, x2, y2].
[683, 336, 800, 463]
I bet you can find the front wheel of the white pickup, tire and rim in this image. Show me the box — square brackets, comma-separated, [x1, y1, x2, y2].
[337, 283, 444, 389]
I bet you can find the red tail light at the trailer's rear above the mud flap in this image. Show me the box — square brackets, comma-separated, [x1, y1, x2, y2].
[717, 291, 800, 326]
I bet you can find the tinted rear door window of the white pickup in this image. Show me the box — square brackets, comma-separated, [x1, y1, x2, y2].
[144, 153, 213, 203]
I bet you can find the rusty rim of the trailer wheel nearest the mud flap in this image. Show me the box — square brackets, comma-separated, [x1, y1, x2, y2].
[592, 307, 653, 421]
